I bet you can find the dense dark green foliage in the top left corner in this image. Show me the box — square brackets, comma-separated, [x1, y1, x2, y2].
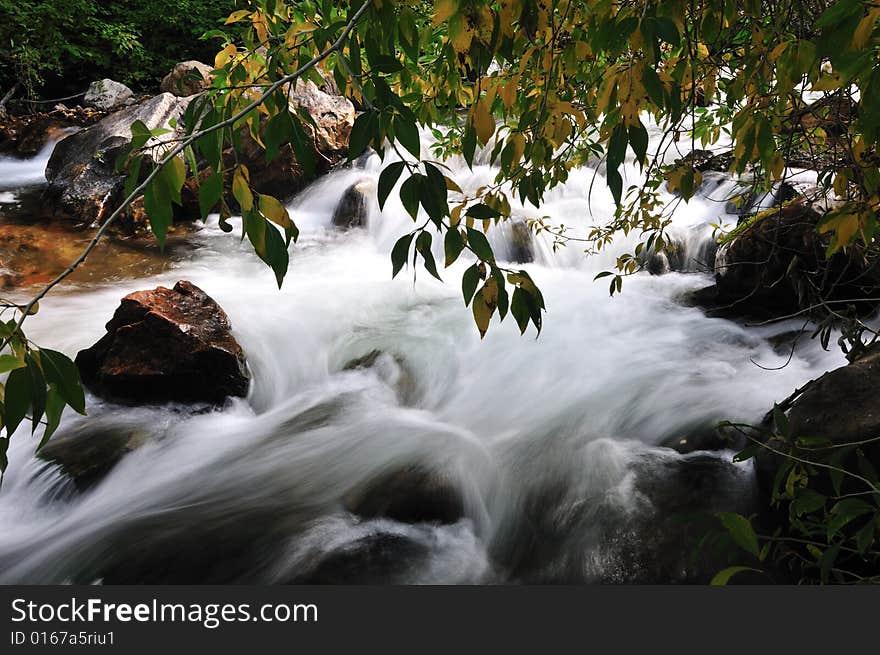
[0, 0, 241, 97]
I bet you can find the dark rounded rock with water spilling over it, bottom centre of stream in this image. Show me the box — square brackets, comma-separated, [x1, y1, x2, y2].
[345, 466, 465, 524]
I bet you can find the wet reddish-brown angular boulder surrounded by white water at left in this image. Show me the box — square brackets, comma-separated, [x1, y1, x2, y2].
[76, 280, 248, 403]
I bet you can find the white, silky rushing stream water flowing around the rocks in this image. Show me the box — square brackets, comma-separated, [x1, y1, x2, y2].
[0, 128, 841, 583]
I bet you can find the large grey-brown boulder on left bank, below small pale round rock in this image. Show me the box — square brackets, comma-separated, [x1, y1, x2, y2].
[44, 93, 189, 224]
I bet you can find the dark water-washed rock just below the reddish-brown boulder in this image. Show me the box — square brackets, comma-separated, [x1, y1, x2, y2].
[38, 421, 149, 491]
